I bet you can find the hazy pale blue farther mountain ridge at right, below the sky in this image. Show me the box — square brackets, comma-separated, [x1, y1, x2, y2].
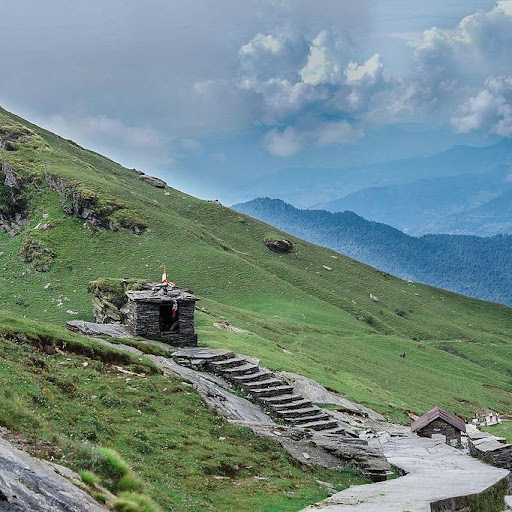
[315, 164, 512, 236]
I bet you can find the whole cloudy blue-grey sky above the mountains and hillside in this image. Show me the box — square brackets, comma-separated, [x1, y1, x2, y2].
[0, 0, 512, 204]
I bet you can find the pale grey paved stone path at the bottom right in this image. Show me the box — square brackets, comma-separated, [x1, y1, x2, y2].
[305, 434, 509, 512]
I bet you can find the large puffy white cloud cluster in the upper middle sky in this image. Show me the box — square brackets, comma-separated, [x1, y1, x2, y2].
[195, 30, 394, 157]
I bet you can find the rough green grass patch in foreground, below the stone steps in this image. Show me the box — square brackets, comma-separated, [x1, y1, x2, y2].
[0, 329, 367, 512]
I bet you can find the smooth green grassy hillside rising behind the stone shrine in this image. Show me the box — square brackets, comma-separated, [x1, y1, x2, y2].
[0, 105, 512, 428]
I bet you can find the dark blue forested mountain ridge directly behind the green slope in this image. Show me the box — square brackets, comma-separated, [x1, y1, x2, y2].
[233, 198, 512, 305]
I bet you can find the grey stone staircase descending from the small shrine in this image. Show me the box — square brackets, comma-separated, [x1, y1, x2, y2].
[172, 348, 346, 435]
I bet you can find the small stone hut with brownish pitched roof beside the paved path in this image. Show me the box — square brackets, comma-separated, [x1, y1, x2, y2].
[411, 407, 466, 447]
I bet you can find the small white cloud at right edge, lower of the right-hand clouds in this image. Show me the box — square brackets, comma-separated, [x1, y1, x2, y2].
[452, 77, 512, 137]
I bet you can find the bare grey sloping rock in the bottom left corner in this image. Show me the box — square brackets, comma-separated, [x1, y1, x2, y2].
[0, 430, 108, 512]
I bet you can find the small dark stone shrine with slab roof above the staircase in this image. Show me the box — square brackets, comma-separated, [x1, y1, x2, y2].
[125, 283, 199, 347]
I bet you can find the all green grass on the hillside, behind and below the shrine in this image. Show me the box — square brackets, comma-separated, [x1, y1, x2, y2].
[0, 106, 512, 511]
